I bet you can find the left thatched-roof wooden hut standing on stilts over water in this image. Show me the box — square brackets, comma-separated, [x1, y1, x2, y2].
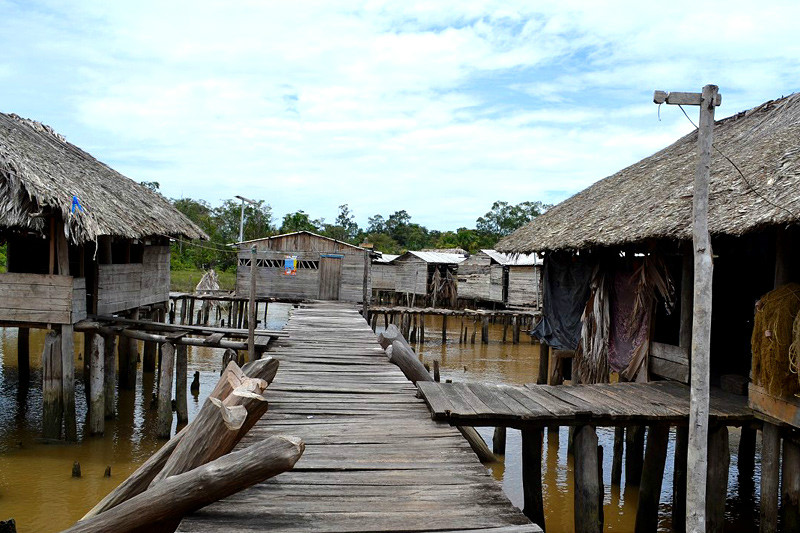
[0, 113, 207, 440]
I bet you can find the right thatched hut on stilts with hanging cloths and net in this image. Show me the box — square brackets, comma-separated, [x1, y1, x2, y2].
[496, 94, 800, 531]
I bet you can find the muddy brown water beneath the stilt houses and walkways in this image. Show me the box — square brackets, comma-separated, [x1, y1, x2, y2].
[0, 304, 760, 533]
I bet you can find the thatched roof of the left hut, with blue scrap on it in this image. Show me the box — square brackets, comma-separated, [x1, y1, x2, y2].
[0, 113, 208, 243]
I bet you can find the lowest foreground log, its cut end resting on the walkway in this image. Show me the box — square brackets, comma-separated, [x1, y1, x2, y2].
[63, 436, 305, 533]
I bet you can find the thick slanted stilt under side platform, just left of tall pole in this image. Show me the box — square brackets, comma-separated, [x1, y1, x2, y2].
[635, 424, 672, 533]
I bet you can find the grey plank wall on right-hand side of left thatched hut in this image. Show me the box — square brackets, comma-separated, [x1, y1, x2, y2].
[97, 246, 170, 315]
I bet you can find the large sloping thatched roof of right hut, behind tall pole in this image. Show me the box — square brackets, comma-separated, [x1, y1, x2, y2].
[495, 94, 800, 252]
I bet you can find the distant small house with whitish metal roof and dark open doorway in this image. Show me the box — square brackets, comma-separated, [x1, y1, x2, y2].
[392, 251, 466, 306]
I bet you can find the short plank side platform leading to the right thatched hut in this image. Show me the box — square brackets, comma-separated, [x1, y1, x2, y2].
[418, 381, 754, 428]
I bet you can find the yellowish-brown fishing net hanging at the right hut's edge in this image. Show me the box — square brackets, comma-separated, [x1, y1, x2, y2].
[751, 283, 800, 398]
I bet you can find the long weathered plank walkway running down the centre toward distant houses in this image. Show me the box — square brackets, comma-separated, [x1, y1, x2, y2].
[178, 302, 541, 533]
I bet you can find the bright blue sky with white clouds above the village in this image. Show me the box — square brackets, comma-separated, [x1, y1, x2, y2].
[0, 0, 800, 230]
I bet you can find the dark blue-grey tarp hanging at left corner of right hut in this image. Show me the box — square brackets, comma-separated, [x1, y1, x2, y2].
[531, 253, 592, 350]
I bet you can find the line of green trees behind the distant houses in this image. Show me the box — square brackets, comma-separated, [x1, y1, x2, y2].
[161, 183, 550, 270]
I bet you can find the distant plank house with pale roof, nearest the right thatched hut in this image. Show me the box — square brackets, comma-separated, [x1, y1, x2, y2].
[458, 250, 542, 307]
